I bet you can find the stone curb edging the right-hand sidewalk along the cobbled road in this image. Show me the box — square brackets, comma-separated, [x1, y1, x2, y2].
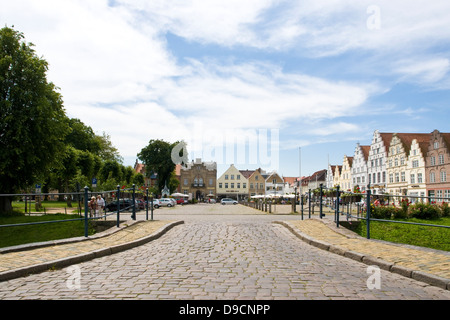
[273, 221, 450, 290]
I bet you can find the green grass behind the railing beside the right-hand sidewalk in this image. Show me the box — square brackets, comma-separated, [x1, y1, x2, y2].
[352, 217, 450, 251]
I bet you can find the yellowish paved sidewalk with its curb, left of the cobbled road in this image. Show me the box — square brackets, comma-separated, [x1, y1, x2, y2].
[0, 221, 184, 281]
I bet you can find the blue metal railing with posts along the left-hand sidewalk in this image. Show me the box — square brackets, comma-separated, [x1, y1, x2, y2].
[0, 185, 154, 237]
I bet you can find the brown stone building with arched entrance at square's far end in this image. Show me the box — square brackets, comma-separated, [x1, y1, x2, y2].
[180, 159, 217, 201]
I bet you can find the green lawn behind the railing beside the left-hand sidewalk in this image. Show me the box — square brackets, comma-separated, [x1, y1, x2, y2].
[0, 214, 95, 248]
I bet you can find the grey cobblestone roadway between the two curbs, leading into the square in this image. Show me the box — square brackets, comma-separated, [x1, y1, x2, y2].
[0, 205, 450, 300]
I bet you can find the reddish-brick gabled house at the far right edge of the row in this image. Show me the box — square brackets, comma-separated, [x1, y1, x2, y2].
[425, 130, 450, 203]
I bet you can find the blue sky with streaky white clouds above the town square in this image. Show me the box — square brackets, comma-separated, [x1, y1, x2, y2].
[0, 0, 450, 176]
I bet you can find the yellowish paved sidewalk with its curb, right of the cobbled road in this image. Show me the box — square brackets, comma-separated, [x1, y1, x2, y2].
[274, 215, 450, 290]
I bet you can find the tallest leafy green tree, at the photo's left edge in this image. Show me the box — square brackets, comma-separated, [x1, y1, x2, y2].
[0, 27, 69, 212]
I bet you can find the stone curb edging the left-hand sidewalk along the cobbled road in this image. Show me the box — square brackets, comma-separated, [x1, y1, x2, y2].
[0, 221, 184, 282]
